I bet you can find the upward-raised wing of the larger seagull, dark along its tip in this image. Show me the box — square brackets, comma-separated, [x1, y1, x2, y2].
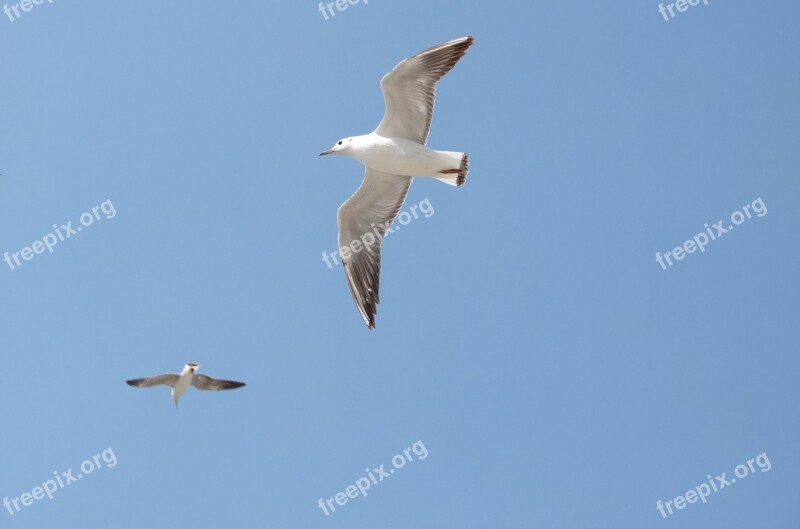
[375, 37, 475, 145]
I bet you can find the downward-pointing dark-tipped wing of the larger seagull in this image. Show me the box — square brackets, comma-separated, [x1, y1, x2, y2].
[338, 167, 413, 329]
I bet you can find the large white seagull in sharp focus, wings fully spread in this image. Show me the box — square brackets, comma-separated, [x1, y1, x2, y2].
[320, 37, 474, 329]
